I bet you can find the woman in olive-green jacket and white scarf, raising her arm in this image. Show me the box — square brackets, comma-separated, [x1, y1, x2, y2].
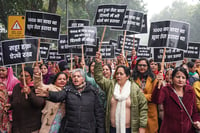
[94, 52, 147, 133]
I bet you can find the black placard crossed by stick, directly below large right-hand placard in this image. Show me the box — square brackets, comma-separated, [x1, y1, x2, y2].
[154, 48, 184, 62]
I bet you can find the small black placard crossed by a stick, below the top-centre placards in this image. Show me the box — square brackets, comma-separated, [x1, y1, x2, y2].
[118, 36, 140, 51]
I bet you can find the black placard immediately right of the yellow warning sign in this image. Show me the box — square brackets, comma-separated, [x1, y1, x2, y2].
[25, 11, 60, 40]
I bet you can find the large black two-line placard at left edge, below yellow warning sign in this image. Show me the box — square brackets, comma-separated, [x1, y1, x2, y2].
[2, 38, 38, 66]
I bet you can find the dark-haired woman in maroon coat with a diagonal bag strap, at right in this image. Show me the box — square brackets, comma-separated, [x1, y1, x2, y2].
[152, 67, 200, 133]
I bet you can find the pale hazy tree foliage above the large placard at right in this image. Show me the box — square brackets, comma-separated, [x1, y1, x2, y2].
[151, 0, 200, 42]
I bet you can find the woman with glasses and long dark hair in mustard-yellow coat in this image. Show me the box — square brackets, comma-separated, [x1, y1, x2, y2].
[133, 58, 158, 133]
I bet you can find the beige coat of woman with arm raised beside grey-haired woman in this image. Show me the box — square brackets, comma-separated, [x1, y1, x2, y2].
[34, 75, 65, 133]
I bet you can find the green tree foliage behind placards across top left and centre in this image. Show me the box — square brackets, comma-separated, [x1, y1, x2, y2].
[0, 0, 146, 40]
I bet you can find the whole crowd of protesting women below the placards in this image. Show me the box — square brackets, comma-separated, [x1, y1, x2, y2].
[0, 49, 200, 133]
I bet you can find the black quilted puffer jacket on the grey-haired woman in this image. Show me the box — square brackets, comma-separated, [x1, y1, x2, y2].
[49, 83, 105, 133]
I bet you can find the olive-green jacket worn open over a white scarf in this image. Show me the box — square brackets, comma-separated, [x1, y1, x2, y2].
[94, 62, 148, 133]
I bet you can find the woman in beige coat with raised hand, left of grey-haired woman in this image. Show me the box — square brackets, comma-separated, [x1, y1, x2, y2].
[34, 66, 68, 133]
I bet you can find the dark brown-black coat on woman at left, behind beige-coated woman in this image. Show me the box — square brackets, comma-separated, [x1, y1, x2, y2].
[10, 84, 45, 133]
